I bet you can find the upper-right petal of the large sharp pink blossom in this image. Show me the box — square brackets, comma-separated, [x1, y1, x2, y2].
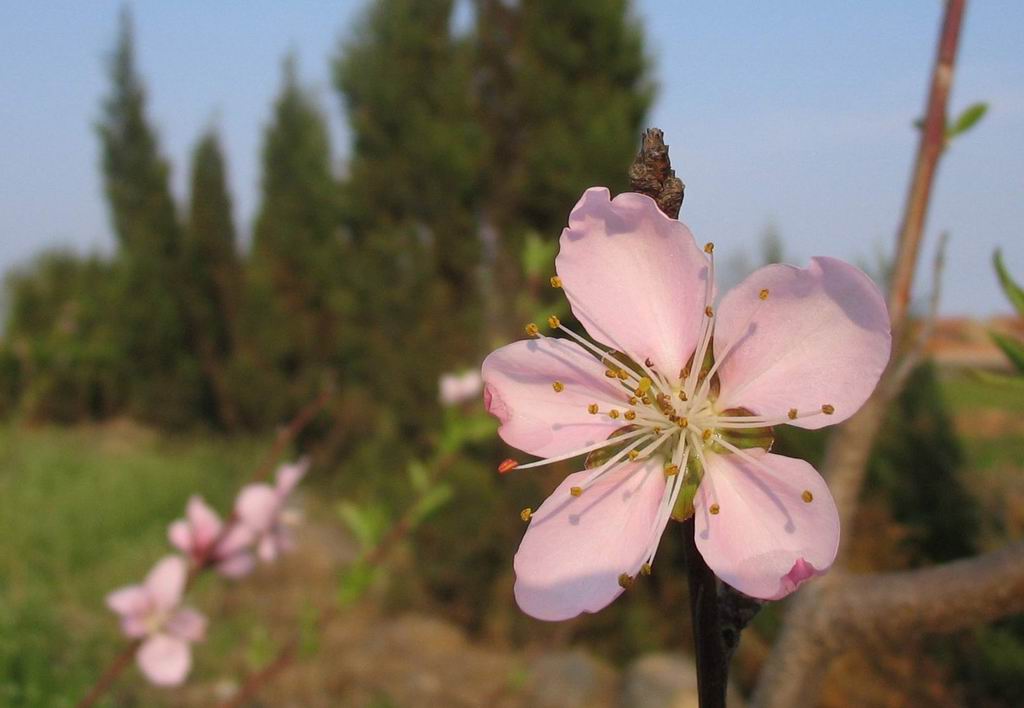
[715, 258, 891, 428]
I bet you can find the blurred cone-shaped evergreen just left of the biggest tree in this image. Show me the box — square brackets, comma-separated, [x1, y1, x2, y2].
[247, 57, 345, 411]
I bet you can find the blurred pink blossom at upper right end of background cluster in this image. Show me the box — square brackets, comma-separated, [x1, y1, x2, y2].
[234, 459, 309, 563]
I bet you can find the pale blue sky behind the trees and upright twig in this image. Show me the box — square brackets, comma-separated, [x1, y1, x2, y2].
[0, 0, 1024, 316]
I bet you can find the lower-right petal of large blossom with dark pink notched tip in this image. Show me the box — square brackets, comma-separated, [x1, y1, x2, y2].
[693, 450, 839, 599]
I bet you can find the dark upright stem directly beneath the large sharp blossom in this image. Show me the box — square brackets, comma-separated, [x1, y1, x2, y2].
[682, 516, 729, 708]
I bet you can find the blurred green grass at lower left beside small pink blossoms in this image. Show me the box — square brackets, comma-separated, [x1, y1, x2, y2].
[0, 425, 265, 706]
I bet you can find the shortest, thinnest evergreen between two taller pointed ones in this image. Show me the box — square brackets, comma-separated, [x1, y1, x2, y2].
[183, 130, 243, 428]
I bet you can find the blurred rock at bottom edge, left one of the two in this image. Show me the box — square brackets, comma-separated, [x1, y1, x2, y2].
[523, 650, 618, 708]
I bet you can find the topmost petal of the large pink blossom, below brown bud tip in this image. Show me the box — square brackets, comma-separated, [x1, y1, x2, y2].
[555, 186, 708, 376]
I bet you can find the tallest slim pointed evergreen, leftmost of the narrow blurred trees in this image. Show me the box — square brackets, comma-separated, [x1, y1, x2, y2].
[98, 11, 201, 425]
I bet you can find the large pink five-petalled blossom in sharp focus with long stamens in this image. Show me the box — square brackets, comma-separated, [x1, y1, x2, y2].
[482, 188, 890, 620]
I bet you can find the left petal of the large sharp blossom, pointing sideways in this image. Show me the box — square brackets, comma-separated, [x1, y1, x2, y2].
[482, 337, 628, 457]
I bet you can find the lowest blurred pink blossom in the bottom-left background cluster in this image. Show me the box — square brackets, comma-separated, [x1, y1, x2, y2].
[106, 555, 206, 685]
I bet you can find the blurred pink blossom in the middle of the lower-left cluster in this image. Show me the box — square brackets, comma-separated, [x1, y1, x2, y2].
[167, 496, 255, 578]
